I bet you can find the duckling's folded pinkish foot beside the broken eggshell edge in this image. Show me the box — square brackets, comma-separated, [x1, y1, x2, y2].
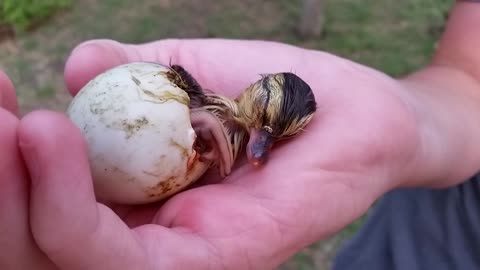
[190, 108, 233, 177]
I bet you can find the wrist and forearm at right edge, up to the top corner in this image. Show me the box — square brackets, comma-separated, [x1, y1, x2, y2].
[390, 1, 480, 186]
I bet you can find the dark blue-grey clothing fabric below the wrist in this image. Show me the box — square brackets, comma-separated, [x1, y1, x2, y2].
[333, 175, 480, 270]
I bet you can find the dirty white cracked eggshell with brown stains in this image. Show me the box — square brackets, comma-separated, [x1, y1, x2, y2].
[67, 62, 208, 204]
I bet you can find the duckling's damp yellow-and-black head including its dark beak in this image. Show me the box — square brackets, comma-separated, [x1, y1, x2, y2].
[236, 72, 317, 166]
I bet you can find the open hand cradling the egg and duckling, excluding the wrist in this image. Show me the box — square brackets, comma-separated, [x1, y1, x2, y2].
[19, 40, 428, 269]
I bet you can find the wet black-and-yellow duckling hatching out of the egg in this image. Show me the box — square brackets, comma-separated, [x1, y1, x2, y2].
[167, 65, 317, 177]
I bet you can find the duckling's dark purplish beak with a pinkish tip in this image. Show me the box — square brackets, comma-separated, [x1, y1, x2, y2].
[247, 129, 273, 167]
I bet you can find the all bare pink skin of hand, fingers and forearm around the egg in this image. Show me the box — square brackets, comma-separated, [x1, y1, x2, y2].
[0, 1, 480, 269]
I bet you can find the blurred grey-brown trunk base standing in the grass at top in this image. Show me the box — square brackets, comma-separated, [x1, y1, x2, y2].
[298, 0, 325, 37]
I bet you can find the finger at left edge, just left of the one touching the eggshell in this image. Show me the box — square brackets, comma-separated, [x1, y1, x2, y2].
[0, 108, 54, 269]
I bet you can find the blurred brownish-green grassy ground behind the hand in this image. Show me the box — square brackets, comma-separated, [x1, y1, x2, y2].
[0, 0, 454, 270]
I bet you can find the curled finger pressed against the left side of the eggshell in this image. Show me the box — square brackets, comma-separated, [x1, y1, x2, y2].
[18, 111, 147, 270]
